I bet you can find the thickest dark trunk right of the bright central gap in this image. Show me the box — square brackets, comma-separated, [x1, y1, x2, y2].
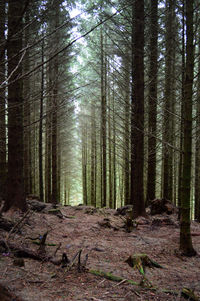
[131, 0, 146, 217]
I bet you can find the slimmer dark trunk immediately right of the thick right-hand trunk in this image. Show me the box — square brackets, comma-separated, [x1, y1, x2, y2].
[146, 0, 158, 205]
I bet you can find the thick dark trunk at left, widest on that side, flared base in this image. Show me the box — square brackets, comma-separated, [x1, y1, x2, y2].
[3, 0, 27, 211]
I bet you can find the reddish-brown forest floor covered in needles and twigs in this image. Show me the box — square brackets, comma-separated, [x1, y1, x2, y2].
[0, 200, 200, 301]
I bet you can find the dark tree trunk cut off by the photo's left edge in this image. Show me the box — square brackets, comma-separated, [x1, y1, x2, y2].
[0, 0, 7, 198]
